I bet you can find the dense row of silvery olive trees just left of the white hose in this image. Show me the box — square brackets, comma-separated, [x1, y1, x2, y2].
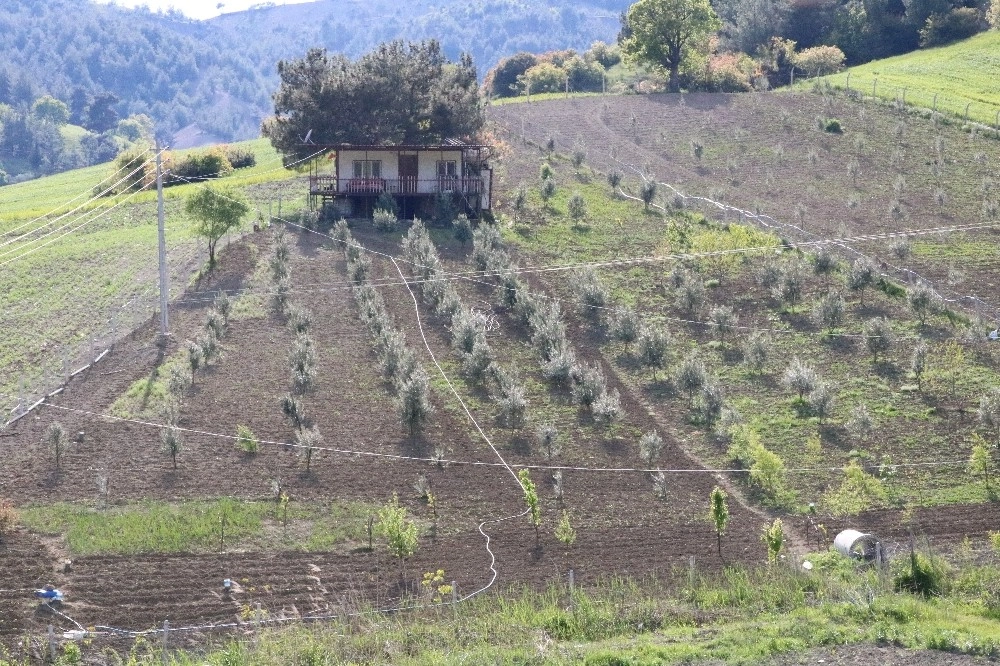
[333, 220, 434, 437]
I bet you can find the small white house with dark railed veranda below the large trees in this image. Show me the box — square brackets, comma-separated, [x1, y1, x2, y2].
[309, 139, 493, 217]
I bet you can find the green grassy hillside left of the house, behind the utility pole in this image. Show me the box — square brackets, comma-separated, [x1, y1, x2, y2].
[0, 139, 305, 408]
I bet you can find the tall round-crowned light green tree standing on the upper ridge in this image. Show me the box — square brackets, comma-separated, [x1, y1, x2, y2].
[618, 0, 722, 92]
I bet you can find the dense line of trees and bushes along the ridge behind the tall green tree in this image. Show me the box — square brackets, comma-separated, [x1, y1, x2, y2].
[485, 0, 1000, 97]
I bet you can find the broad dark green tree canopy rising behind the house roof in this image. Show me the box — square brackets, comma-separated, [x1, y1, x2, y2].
[262, 40, 484, 158]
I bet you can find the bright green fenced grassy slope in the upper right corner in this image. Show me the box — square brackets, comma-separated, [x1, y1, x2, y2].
[825, 31, 1000, 126]
